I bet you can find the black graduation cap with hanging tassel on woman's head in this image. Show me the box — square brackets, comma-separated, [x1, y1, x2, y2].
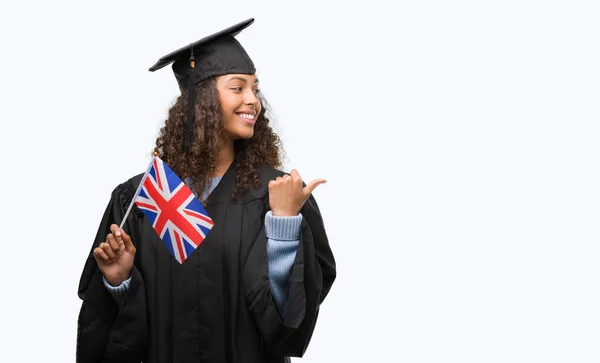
[149, 18, 256, 152]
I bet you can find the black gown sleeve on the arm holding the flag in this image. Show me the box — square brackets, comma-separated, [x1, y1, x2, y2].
[76, 182, 148, 363]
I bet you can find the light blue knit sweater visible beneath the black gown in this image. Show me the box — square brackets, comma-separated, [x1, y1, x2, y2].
[102, 177, 302, 315]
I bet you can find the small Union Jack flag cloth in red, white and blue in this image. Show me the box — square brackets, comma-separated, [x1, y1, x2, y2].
[135, 156, 214, 263]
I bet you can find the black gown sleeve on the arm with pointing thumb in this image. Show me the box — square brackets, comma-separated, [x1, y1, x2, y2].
[244, 195, 336, 357]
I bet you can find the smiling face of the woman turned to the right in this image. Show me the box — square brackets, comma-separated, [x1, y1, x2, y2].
[217, 74, 261, 140]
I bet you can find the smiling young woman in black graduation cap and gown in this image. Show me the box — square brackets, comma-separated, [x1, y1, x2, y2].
[77, 19, 336, 363]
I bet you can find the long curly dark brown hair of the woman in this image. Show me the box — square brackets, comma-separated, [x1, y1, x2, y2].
[154, 77, 284, 200]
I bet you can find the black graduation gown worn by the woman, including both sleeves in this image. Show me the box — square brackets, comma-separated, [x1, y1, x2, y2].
[76, 163, 336, 363]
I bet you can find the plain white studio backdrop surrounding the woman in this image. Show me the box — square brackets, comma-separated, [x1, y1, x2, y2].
[0, 0, 600, 363]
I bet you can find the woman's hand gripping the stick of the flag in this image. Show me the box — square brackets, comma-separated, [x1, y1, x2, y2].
[94, 224, 136, 286]
